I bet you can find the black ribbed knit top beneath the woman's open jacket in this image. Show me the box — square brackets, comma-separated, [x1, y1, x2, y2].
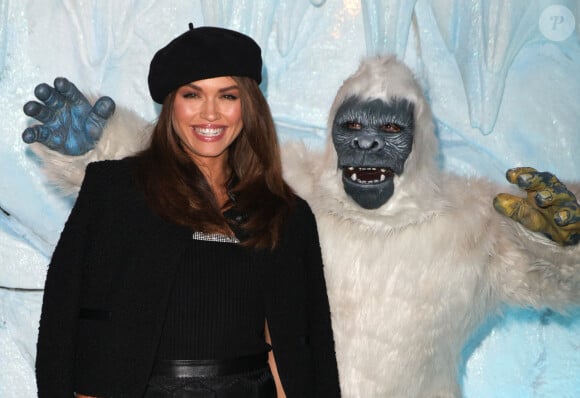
[157, 239, 269, 359]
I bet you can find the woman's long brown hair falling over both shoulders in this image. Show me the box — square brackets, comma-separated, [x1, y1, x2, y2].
[139, 76, 294, 248]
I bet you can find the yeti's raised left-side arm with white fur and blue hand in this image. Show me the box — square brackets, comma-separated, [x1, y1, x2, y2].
[22, 77, 149, 194]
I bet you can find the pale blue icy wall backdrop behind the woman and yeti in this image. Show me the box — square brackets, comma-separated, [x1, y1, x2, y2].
[0, 0, 580, 398]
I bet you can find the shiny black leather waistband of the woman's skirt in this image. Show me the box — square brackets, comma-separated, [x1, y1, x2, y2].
[152, 353, 268, 377]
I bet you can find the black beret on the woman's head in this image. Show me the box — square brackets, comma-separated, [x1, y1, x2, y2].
[147, 24, 262, 104]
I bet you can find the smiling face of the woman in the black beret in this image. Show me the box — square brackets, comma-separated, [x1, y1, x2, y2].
[172, 76, 243, 166]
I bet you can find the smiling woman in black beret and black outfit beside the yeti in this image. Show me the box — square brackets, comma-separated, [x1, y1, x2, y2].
[36, 25, 340, 398]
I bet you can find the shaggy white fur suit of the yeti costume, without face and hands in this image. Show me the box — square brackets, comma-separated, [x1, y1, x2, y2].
[30, 57, 580, 398]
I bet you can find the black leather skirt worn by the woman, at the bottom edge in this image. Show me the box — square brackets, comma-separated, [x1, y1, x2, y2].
[144, 355, 276, 398]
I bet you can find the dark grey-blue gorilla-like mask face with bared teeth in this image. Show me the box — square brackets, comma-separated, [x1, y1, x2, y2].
[332, 96, 414, 209]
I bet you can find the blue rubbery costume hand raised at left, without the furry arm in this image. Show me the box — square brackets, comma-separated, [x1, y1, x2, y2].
[22, 77, 115, 156]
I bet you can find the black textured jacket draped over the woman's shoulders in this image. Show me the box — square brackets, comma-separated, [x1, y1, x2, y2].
[36, 158, 340, 398]
